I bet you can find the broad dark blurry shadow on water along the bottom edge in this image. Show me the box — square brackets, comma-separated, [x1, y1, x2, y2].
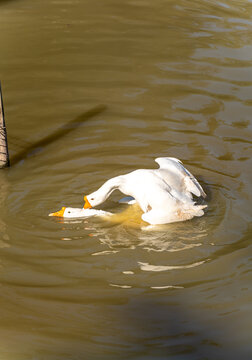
[30, 290, 248, 360]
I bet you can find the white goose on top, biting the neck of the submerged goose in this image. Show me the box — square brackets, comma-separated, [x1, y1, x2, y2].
[84, 157, 207, 225]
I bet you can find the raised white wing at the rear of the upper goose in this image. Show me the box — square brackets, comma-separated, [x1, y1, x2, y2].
[155, 157, 206, 197]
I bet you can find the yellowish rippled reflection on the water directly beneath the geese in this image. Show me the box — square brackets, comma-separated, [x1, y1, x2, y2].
[57, 204, 207, 255]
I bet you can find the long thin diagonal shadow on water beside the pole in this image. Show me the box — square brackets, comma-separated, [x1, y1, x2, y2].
[10, 105, 106, 166]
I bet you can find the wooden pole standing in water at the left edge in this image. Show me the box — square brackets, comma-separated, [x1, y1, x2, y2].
[0, 82, 10, 169]
